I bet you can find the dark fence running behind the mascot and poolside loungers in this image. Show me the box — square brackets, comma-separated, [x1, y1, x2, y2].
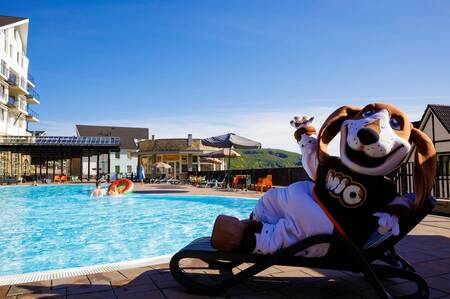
[188, 161, 450, 199]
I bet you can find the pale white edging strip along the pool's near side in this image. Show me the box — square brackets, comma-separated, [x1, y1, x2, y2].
[0, 254, 173, 286]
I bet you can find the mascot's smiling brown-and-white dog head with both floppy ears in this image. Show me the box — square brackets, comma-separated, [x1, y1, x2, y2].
[318, 103, 436, 209]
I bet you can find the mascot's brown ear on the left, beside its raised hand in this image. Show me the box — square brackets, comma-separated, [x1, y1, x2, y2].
[317, 106, 361, 163]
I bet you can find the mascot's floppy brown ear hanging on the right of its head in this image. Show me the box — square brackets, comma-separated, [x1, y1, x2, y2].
[411, 128, 436, 209]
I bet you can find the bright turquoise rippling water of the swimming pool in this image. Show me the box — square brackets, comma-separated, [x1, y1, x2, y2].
[0, 185, 255, 275]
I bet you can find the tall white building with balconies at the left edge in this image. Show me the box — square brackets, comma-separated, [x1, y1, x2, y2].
[0, 16, 39, 176]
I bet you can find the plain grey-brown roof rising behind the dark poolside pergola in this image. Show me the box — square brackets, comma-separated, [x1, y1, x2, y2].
[76, 125, 148, 149]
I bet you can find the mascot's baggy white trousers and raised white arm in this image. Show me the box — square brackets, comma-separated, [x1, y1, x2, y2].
[253, 135, 334, 257]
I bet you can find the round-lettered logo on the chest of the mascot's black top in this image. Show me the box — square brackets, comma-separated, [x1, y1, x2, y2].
[325, 170, 367, 208]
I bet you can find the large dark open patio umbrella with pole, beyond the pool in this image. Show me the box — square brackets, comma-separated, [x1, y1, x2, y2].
[202, 133, 261, 188]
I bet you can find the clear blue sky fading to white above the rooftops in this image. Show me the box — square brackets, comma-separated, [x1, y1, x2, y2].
[0, 0, 450, 150]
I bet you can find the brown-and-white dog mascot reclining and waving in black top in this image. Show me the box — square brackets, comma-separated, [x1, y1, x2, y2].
[211, 103, 436, 257]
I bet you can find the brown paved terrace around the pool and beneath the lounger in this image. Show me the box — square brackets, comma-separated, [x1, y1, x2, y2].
[0, 185, 450, 298]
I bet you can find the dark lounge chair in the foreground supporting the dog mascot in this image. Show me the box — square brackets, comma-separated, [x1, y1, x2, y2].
[170, 197, 436, 299]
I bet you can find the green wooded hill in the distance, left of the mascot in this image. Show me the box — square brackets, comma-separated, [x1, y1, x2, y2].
[229, 148, 301, 169]
